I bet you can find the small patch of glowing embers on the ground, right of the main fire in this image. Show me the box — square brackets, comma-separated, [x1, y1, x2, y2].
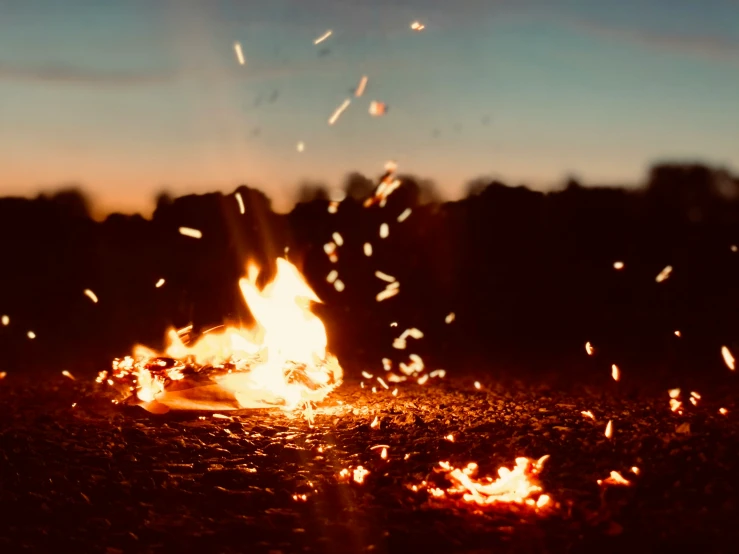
[411, 456, 552, 509]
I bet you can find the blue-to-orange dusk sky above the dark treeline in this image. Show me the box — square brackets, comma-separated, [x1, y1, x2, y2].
[0, 0, 739, 213]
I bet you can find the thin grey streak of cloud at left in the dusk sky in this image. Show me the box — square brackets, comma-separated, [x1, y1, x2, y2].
[0, 63, 178, 87]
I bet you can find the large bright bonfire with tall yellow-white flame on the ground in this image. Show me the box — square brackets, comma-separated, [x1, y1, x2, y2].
[98, 258, 342, 419]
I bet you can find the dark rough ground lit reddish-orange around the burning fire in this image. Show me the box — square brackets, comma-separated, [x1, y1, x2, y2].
[0, 375, 739, 553]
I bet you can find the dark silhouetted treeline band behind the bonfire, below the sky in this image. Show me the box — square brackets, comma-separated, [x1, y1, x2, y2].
[0, 164, 739, 379]
